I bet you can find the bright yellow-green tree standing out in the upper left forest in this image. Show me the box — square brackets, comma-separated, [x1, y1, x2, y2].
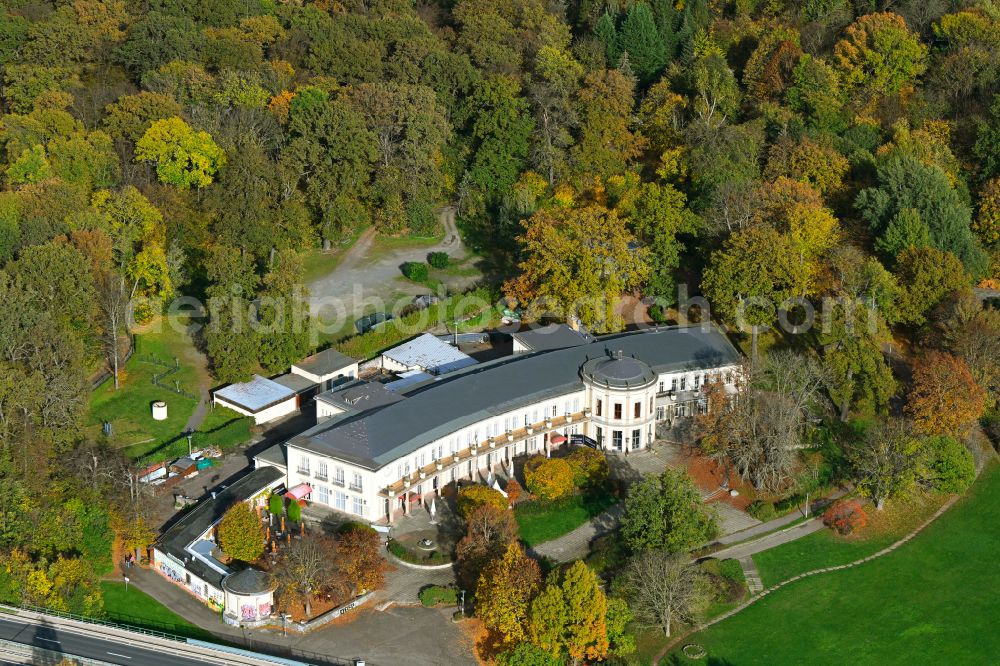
[135, 117, 226, 190]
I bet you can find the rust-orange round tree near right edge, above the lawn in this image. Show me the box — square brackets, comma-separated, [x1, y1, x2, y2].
[906, 351, 986, 435]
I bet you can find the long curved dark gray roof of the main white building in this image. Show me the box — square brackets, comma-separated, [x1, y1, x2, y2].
[288, 326, 740, 469]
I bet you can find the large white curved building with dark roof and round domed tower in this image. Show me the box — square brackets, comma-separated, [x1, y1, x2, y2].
[256, 326, 741, 522]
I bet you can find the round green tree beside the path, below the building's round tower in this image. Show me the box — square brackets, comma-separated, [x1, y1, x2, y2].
[622, 469, 719, 553]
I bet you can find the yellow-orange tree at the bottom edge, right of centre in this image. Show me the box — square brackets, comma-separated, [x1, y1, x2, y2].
[528, 560, 610, 663]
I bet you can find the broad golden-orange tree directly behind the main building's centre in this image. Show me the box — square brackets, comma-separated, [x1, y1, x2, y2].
[504, 204, 649, 331]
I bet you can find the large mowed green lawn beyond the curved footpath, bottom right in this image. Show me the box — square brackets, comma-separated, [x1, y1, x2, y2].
[666, 465, 1000, 666]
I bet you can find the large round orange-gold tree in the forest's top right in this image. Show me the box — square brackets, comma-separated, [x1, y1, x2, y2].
[834, 12, 927, 104]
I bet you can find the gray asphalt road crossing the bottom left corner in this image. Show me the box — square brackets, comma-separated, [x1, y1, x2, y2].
[0, 618, 204, 666]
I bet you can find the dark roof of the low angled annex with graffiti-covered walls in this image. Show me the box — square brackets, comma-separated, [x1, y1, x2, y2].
[156, 467, 285, 587]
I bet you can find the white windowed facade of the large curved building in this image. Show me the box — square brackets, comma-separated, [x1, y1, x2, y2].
[278, 365, 736, 521]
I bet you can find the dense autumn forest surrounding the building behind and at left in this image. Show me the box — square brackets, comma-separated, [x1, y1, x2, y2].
[0, 0, 1000, 628]
